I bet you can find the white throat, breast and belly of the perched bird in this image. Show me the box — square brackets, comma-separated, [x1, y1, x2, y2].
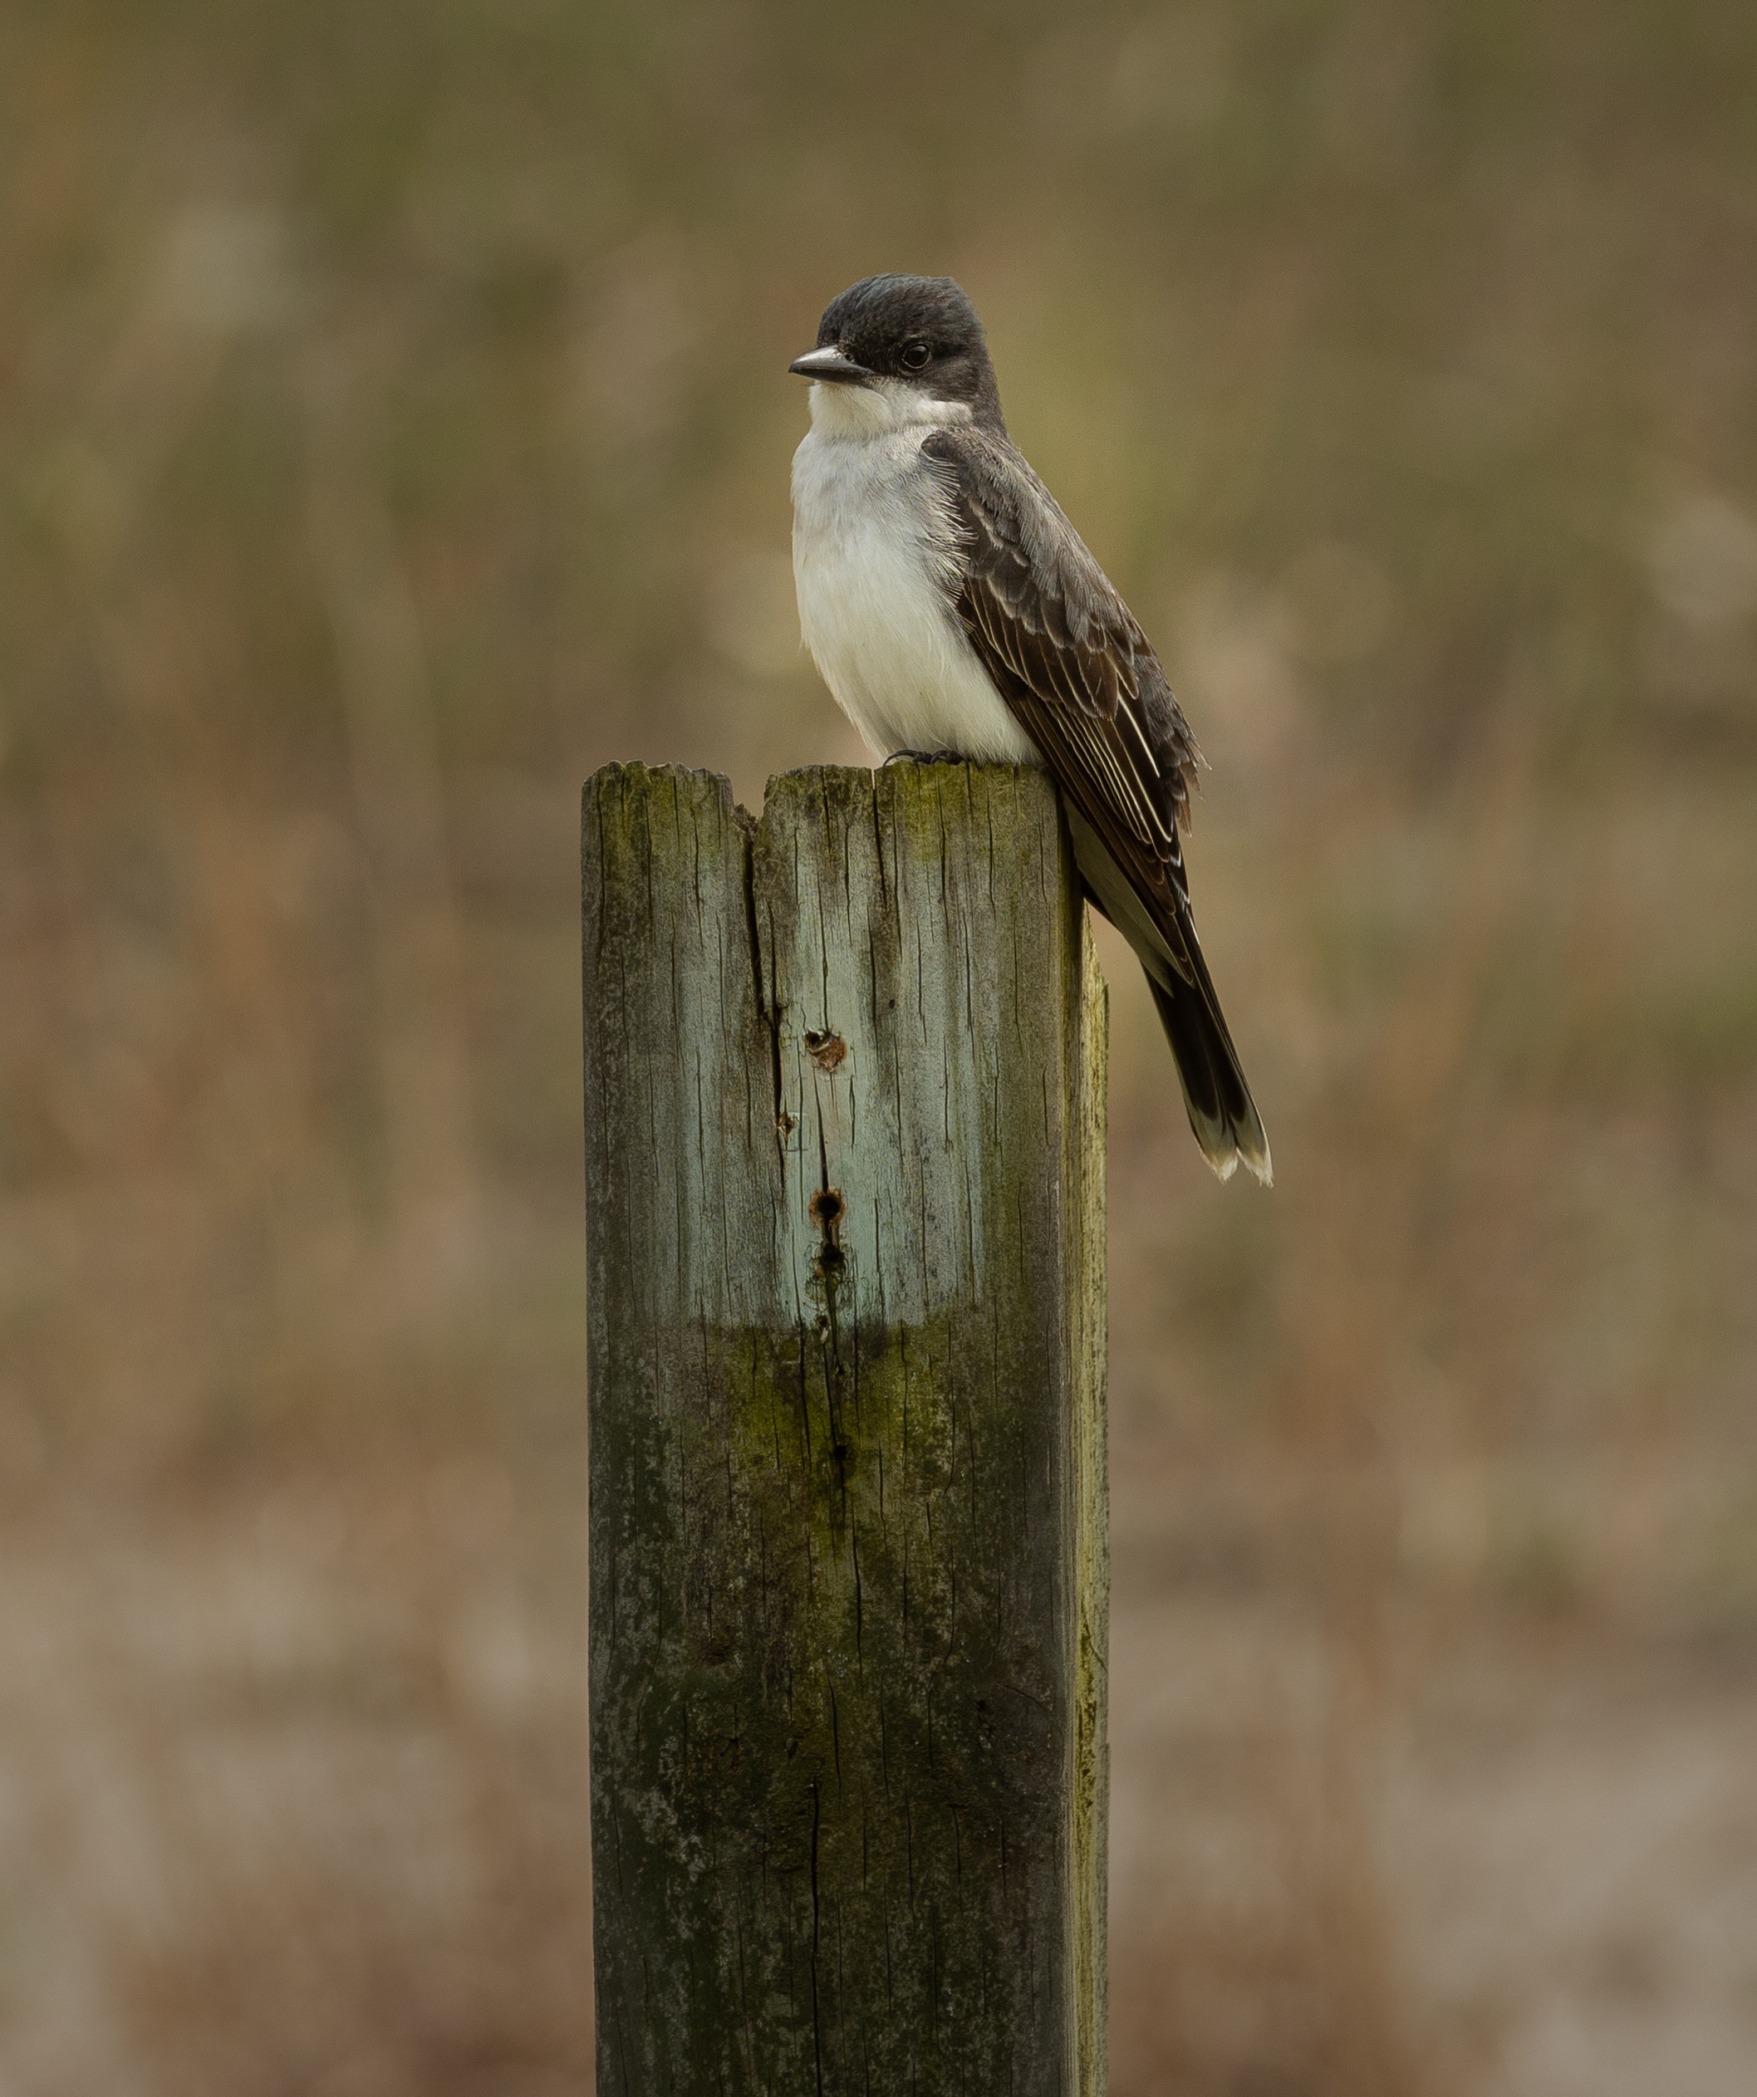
[793, 382, 1038, 763]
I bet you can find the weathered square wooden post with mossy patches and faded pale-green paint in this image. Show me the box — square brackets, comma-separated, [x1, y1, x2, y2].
[583, 765, 1107, 2097]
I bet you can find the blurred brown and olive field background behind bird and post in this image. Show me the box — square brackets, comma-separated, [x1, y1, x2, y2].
[0, 0, 1757, 2097]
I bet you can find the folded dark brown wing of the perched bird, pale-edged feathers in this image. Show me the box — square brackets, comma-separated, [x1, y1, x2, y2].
[923, 428, 1206, 983]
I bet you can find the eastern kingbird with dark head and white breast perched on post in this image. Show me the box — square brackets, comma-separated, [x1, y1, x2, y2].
[788, 277, 1271, 1183]
